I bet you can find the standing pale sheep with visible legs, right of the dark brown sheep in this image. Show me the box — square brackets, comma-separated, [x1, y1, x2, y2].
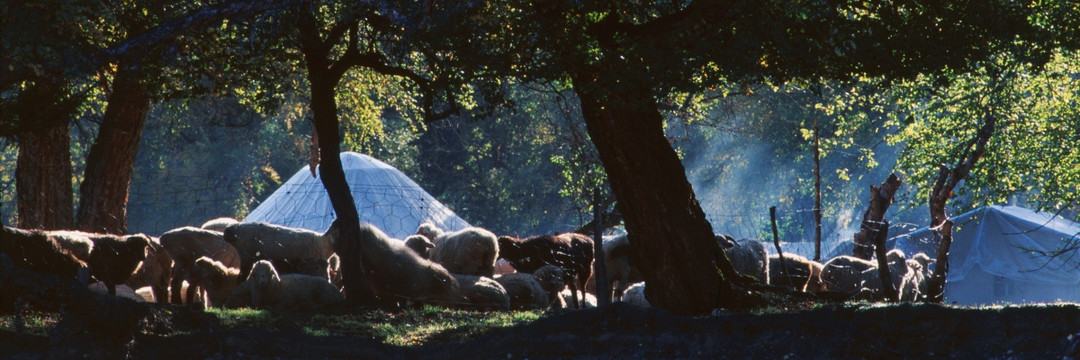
[159, 226, 240, 304]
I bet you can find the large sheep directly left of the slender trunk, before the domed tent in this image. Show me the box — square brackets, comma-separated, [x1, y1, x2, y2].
[225, 221, 339, 279]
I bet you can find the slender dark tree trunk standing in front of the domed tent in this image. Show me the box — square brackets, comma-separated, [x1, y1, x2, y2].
[299, 4, 377, 305]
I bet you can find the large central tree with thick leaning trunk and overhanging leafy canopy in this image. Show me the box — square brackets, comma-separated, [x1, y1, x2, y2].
[488, 1, 1067, 314]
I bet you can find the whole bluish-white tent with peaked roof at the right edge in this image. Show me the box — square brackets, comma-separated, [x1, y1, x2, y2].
[895, 205, 1080, 305]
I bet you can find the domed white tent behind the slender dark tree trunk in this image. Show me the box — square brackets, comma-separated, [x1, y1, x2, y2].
[244, 151, 469, 239]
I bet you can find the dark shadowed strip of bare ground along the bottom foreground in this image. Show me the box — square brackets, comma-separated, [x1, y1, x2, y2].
[6, 304, 1080, 359]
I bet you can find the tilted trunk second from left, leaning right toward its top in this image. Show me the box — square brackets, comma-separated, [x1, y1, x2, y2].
[76, 67, 150, 234]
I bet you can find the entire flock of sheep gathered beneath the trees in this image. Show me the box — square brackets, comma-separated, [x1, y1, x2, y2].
[0, 218, 931, 310]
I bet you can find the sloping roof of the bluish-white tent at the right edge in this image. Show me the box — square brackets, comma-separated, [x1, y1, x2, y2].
[896, 205, 1080, 285]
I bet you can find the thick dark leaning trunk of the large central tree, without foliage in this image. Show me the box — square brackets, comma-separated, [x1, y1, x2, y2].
[573, 71, 734, 315]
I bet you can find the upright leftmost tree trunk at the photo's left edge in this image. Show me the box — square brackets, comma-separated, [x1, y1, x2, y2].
[15, 80, 75, 229]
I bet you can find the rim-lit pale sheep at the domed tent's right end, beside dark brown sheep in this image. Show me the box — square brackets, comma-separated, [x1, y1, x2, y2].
[417, 223, 499, 278]
